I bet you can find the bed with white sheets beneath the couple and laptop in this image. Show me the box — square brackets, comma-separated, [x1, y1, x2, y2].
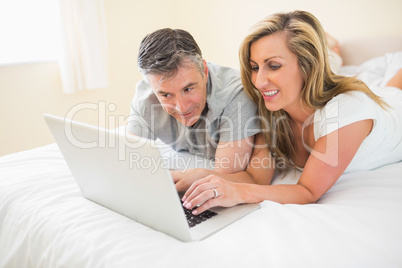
[0, 37, 402, 268]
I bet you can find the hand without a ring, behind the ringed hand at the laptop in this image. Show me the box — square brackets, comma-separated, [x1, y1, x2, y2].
[170, 168, 212, 192]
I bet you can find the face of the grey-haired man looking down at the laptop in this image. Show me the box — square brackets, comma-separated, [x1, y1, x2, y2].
[147, 61, 208, 126]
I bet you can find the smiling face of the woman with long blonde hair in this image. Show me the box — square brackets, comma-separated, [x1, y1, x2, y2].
[250, 33, 304, 113]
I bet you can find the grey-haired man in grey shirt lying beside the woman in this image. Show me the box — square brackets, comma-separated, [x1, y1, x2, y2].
[127, 29, 259, 177]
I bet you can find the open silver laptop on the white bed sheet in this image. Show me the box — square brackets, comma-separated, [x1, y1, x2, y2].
[44, 114, 260, 242]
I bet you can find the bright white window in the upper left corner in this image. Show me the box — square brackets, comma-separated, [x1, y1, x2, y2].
[0, 0, 61, 65]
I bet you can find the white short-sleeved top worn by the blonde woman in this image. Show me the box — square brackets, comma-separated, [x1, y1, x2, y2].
[314, 87, 402, 173]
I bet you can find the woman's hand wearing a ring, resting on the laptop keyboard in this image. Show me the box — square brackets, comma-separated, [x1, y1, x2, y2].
[182, 175, 243, 215]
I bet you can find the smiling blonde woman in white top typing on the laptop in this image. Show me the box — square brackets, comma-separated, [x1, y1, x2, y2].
[177, 11, 402, 214]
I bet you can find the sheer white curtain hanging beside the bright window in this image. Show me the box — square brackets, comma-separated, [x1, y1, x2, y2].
[59, 0, 109, 93]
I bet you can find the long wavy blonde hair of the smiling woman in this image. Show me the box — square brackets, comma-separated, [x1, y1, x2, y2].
[239, 11, 386, 170]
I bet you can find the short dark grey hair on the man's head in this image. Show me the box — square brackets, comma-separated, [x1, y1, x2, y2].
[137, 28, 204, 77]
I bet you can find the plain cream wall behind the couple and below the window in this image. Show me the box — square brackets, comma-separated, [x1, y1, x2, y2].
[0, 0, 402, 155]
